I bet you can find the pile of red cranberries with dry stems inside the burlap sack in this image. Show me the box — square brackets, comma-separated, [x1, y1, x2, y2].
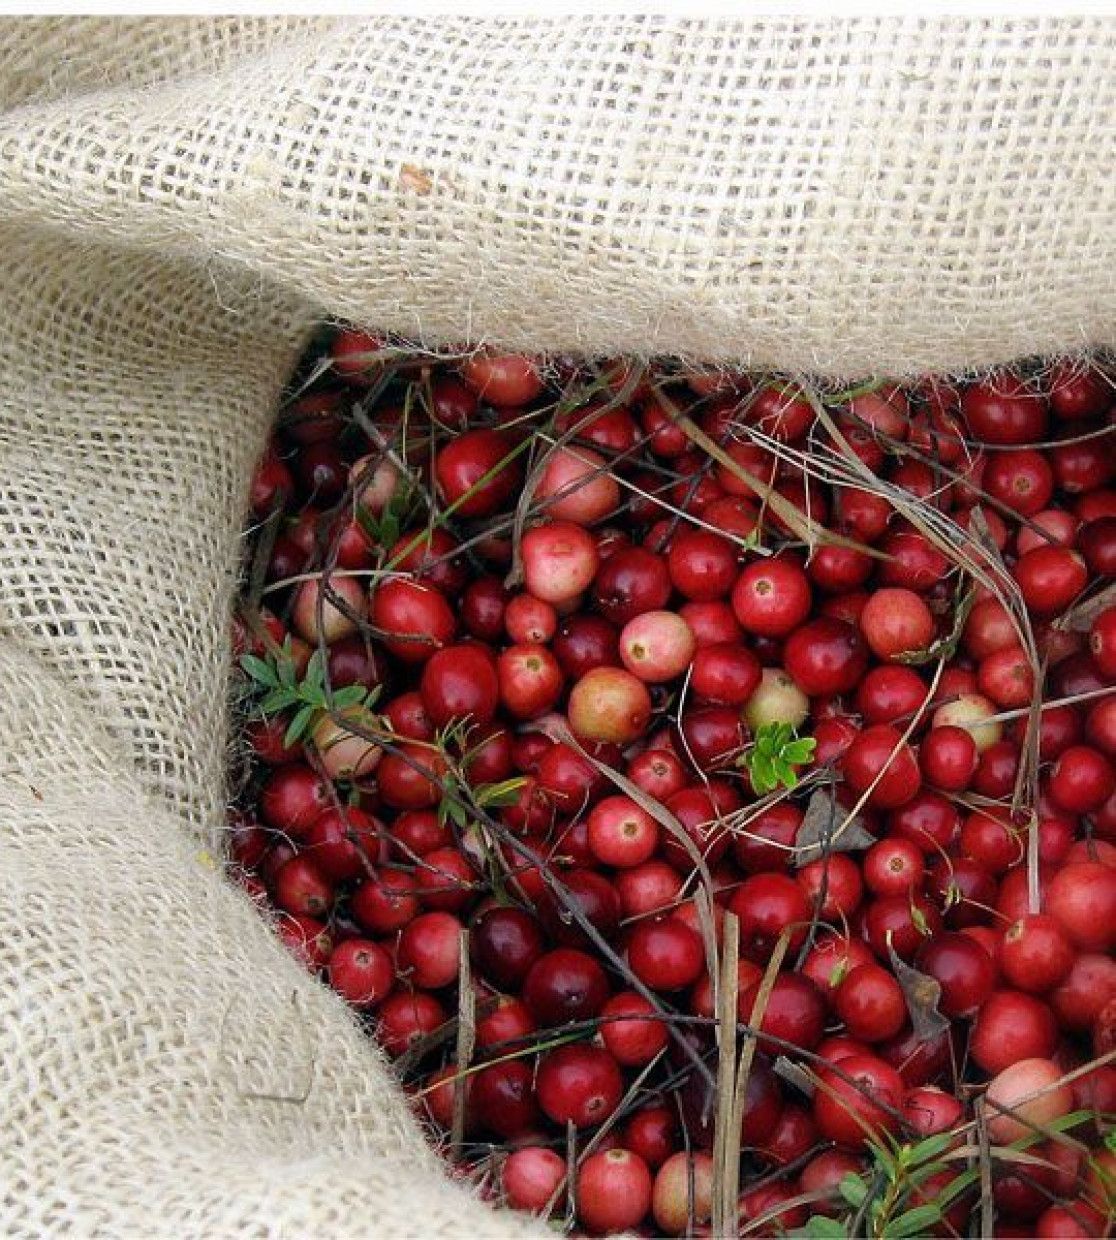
[231, 330, 1116, 1236]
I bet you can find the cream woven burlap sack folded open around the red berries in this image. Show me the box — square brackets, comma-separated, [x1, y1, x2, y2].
[0, 17, 1116, 1238]
